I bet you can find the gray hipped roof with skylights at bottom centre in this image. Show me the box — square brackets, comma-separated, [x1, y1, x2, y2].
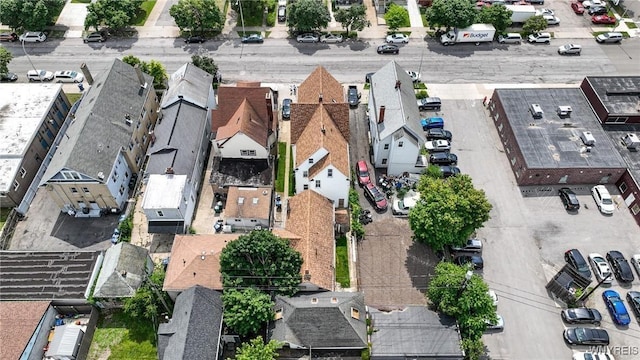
[269, 292, 367, 349]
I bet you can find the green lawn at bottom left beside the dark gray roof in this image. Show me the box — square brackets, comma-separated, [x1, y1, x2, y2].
[87, 311, 157, 360]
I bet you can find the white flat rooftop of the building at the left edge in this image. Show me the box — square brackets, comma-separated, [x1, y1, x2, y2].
[0, 84, 62, 192]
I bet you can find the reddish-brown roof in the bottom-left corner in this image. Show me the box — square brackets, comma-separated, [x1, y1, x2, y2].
[0, 301, 49, 359]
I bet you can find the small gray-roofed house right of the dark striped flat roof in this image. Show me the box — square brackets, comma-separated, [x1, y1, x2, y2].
[93, 242, 153, 300]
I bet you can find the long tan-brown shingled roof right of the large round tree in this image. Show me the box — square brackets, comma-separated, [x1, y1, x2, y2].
[279, 190, 335, 291]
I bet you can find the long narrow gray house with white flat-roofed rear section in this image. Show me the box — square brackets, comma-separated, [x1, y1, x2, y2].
[142, 64, 216, 234]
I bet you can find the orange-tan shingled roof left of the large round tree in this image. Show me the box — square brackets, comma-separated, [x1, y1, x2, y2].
[162, 233, 242, 291]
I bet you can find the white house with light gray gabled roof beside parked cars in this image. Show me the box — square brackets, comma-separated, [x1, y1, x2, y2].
[368, 61, 429, 175]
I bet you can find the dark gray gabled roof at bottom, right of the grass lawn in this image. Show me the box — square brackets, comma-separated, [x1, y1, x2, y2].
[158, 286, 222, 360]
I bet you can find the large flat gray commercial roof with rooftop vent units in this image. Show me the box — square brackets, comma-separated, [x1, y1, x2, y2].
[496, 88, 626, 169]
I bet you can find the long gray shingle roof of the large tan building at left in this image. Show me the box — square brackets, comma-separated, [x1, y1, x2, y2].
[44, 59, 154, 180]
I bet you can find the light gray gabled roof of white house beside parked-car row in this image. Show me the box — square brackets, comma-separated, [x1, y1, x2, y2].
[369, 61, 422, 140]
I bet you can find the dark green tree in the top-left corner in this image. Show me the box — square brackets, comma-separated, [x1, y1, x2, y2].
[0, 0, 66, 32]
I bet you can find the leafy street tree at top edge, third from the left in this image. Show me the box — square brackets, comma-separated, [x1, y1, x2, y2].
[169, 0, 225, 34]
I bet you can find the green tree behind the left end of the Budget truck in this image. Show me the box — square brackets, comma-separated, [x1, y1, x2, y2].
[425, 0, 478, 29]
